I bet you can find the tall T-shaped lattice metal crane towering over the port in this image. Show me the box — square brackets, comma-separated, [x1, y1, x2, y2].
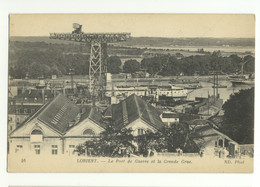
[50, 23, 131, 103]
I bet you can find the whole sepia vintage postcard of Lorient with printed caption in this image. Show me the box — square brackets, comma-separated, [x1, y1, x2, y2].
[7, 14, 255, 173]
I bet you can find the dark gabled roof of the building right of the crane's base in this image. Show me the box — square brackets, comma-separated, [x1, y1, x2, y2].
[112, 94, 164, 130]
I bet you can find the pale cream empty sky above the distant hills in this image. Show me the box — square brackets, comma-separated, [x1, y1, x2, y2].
[9, 14, 255, 38]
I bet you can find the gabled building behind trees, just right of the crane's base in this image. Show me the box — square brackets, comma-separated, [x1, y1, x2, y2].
[105, 94, 164, 136]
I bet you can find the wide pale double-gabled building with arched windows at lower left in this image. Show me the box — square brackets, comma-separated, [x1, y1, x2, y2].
[9, 94, 105, 155]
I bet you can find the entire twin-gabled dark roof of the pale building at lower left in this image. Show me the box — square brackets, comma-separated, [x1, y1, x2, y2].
[10, 94, 105, 134]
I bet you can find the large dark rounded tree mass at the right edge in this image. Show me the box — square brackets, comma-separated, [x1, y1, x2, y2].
[222, 88, 254, 144]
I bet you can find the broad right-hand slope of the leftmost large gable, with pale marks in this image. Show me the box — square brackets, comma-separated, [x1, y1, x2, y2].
[38, 94, 80, 134]
